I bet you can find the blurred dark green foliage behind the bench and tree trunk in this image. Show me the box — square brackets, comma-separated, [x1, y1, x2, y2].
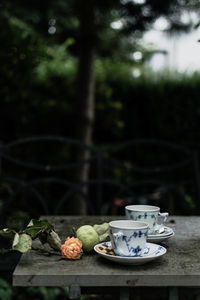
[0, 0, 200, 299]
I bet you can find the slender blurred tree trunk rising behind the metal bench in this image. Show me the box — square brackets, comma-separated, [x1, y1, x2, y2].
[72, 0, 95, 215]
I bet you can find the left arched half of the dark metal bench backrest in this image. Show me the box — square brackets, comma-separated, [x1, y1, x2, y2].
[0, 136, 100, 226]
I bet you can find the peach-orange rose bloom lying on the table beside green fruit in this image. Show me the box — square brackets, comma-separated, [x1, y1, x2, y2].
[61, 237, 82, 259]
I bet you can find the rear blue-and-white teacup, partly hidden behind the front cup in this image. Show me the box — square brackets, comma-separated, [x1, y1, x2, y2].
[125, 205, 169, 234]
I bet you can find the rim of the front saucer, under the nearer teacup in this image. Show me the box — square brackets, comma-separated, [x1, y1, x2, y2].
[94, 241, 167, 261]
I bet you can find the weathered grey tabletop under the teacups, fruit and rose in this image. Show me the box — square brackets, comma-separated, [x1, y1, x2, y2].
[13, 216, 200, 287]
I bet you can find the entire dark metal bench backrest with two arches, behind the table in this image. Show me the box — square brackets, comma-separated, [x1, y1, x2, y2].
[0, 136, 200, 227]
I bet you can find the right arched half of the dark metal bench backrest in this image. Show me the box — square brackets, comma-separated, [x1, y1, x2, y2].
[101, 139, 200, 214]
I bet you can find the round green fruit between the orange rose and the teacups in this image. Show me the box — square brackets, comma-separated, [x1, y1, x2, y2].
[76, 225, 99, 252]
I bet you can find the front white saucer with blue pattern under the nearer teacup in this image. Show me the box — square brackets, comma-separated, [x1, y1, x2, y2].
[94, 242, 167, 265]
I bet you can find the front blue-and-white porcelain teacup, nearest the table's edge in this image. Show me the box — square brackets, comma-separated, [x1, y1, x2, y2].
[109, 220, 149, 257]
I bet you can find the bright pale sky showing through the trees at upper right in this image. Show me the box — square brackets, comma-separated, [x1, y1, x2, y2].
[110, 13, 200, 73]
